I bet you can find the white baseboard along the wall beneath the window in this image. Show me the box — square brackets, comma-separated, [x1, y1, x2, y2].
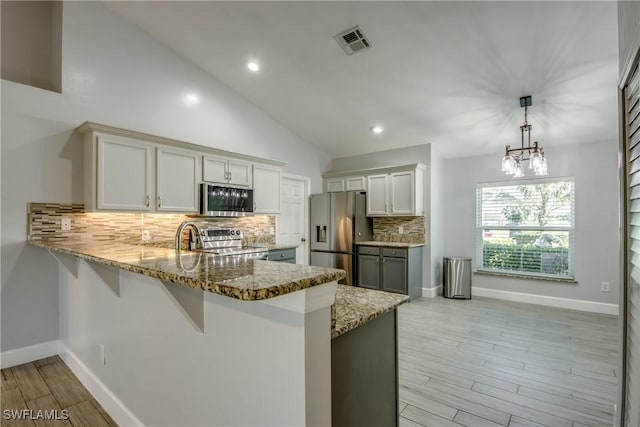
[471, 286, 619, 316]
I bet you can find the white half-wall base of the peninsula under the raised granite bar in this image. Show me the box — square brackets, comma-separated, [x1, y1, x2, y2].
[58, 260, 337, 426]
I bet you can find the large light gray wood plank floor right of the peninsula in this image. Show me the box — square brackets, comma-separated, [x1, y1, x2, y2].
[398, 297, 618, 427]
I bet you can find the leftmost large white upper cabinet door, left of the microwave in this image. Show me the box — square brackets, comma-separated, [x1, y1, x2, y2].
[95, 135, 153, 211]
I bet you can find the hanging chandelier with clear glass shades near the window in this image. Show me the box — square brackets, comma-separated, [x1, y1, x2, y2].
[502, 96, 547, 178]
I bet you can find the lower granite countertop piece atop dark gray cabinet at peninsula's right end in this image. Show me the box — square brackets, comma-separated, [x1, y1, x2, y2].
[331, 285, 409, 339]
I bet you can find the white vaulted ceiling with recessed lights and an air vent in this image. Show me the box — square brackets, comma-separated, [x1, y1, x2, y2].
[105, 1, 618, 157]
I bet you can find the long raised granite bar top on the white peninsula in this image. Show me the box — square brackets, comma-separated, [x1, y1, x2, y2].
[29, 241, 345, 301]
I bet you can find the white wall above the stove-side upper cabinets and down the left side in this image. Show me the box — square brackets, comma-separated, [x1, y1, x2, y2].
[1, 2, 330, 351]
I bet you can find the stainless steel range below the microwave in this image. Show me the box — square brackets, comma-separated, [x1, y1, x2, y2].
[189, 227, 269, 261]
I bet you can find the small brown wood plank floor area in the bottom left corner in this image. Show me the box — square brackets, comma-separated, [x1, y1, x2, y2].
[0, 356, 117, 427]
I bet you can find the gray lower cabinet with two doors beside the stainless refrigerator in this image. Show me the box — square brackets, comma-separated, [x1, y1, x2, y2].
[358, 246, 422, 299]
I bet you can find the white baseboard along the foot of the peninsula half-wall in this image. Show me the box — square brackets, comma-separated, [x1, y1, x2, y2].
[60, 343, 144, 426]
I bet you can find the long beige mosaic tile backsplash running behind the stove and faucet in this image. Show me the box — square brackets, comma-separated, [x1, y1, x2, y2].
[27, 203, 276, 247]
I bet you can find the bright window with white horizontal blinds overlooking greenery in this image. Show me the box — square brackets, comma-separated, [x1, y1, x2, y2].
[476, 178, 575, 280]
